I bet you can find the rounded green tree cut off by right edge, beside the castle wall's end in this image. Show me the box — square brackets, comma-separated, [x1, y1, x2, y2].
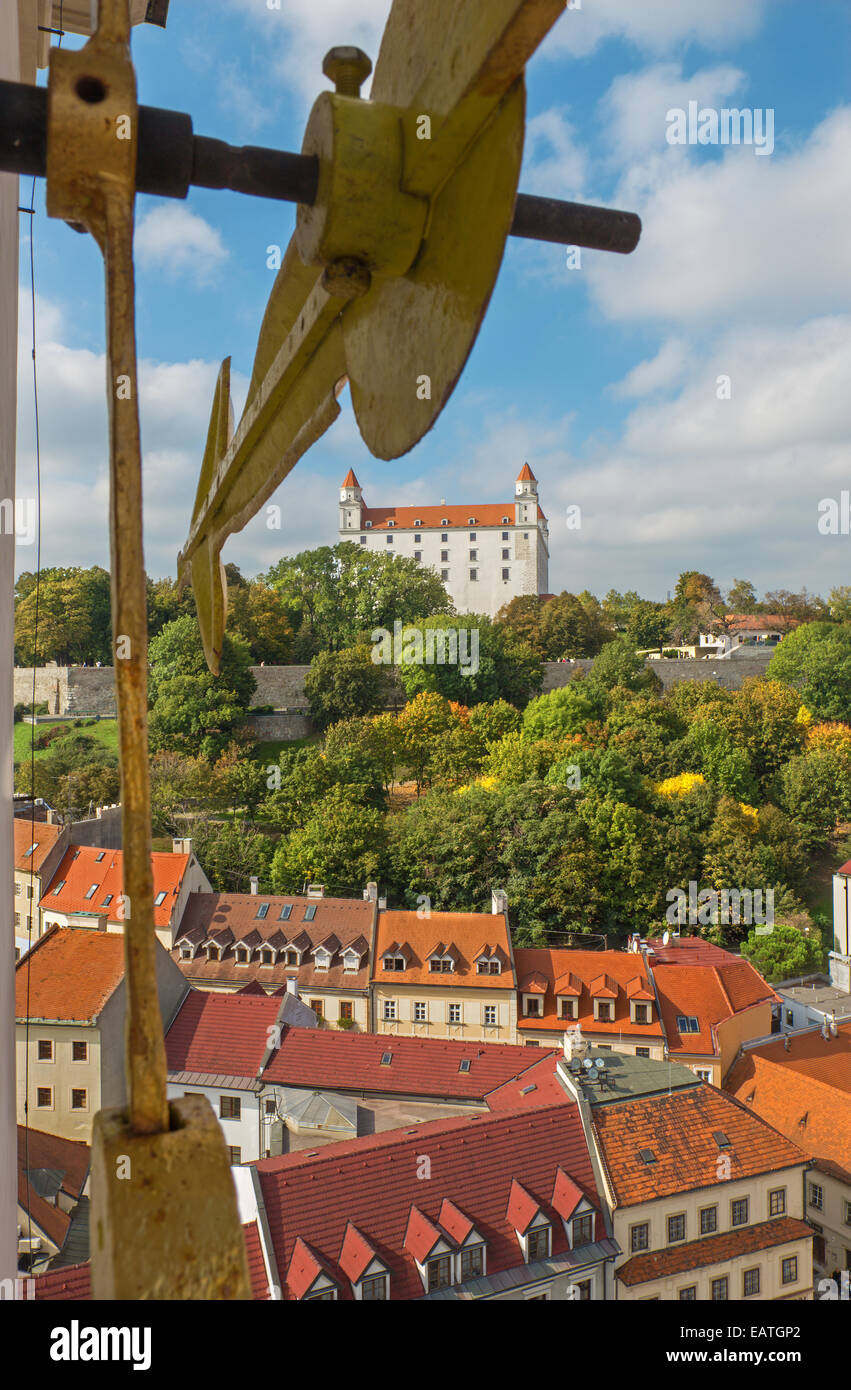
[768, 623, 851, 723]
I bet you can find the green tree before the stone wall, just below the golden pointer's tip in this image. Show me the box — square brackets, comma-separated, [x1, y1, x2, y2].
[147, 617, 256, 760]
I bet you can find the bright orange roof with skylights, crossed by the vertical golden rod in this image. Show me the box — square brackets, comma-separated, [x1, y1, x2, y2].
[39, 845, 189, 927]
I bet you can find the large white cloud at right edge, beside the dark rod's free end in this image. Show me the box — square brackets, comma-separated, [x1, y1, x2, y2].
[587, 107, 851, 332]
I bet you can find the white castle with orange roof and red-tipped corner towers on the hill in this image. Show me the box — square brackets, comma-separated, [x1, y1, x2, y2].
[339, 463, 549, 619]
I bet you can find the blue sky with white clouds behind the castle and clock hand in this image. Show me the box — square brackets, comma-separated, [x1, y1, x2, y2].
[18, 0, 851, 599]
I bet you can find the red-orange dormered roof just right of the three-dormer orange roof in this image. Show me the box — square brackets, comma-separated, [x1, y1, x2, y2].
[514, 947, 662, 1041]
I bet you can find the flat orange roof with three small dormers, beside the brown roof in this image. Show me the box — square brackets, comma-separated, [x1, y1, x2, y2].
[373, 910, 514, 992]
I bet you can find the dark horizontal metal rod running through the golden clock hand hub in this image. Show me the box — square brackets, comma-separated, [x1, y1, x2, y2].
[0, 82, 641, 256]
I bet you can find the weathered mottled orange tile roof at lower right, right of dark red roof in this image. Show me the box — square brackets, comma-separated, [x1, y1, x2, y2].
[594, 1086, 808, 1207]
